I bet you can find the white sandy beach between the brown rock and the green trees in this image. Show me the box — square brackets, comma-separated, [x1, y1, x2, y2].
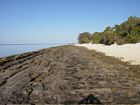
[75, 43, 140, 65]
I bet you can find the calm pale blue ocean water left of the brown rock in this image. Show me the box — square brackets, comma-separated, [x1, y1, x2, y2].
[0, 44, 64, 58]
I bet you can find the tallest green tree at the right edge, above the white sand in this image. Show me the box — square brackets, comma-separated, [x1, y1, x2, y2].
[116, 16, 140, 43]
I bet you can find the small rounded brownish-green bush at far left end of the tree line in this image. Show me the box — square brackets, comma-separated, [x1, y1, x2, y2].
[78, 32, 91, 44]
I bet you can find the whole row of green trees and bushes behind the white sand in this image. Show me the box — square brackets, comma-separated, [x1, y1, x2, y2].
[78, 16, 140, 45]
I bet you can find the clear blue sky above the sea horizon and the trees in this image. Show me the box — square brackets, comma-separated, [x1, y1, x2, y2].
[0, 0, 140, 43]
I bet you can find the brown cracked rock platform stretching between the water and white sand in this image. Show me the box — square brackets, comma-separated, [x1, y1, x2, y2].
[0, 45, 140, 104]
